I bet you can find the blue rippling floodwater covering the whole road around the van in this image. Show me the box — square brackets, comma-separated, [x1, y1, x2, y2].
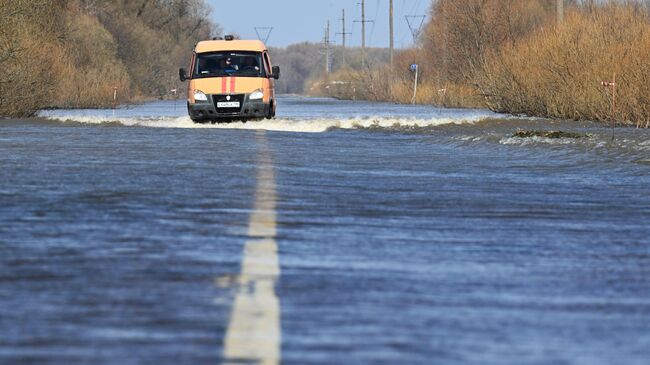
[0, 97, 650, 365]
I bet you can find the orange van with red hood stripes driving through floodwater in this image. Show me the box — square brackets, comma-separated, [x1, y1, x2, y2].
[179, 36, 280, 123]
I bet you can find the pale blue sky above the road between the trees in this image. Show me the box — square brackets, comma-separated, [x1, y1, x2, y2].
[206, 0, 431, 48]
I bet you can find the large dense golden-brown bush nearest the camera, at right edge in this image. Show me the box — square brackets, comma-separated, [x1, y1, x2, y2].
[479, 3, 650, 126]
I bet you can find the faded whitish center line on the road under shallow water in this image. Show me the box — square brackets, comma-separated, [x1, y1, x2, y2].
[223, 131, 282, 365]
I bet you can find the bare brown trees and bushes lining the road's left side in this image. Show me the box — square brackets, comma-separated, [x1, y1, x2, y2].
[0, 0, 220, 116]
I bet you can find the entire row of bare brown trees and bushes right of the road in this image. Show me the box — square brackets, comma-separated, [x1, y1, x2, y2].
[318, 0, 650, 127]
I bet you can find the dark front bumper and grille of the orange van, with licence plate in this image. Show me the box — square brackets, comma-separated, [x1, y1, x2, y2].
[187, 94, 271, 122]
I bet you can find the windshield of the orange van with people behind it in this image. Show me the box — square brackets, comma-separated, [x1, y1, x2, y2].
[193, 52, 266, 78]
